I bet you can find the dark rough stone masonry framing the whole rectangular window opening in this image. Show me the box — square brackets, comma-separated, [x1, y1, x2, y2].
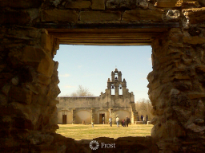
[0, 0, 205, 153]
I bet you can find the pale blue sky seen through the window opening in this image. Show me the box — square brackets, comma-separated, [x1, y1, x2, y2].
[54, 45, 152, 101]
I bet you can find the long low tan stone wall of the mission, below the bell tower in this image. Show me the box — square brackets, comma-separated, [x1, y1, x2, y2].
[56, 96, 133, 124]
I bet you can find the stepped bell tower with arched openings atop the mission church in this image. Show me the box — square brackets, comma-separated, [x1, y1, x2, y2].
[107, 68, 126, 96]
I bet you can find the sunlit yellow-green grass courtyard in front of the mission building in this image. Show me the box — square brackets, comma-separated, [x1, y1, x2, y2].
[56, 124, 153, 140]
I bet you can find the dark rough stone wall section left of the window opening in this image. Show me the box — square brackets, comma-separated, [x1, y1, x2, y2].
[0, 26, 60, 152]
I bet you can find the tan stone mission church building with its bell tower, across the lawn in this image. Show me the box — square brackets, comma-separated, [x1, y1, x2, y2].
[57, 69, 137, 124]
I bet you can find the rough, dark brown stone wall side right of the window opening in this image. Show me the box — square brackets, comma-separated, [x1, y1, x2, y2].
[147, 28, 205, 152]
